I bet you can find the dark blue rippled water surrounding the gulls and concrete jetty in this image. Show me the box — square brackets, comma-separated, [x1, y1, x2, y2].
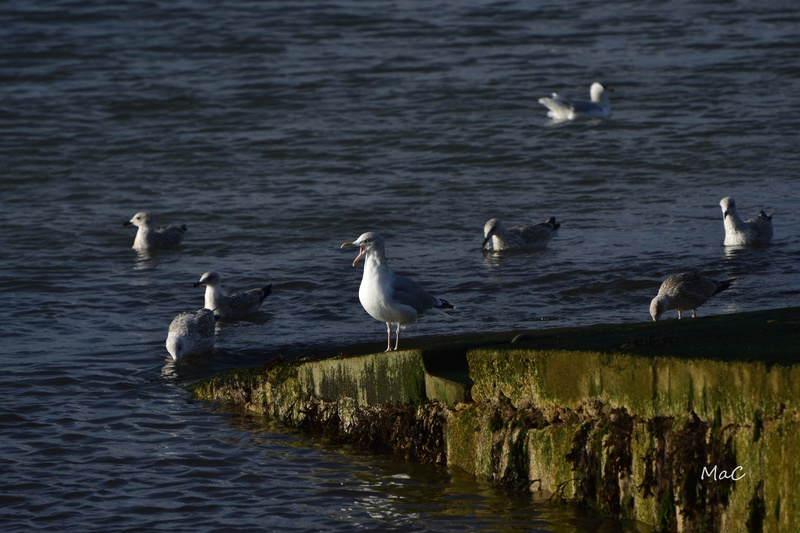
[0, 0, 800, 531]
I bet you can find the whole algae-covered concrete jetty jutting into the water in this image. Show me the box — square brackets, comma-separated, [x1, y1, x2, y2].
[191, 308, 800, 531]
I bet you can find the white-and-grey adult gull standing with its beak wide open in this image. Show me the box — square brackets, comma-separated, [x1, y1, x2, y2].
[341, 231, 454, 352]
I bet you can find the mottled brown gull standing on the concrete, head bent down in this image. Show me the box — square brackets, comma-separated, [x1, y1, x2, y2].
[650, 272, 736, 320]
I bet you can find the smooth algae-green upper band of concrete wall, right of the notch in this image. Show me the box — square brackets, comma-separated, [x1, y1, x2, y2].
[468, 350, 800, 423]
